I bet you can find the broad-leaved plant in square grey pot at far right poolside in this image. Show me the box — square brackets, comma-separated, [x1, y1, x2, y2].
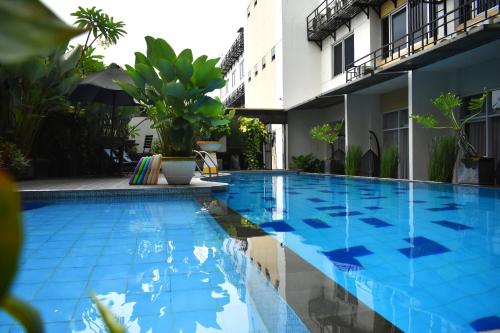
[410, 91, 494, 185]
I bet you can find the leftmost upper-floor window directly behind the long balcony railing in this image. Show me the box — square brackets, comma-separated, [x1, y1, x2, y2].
[382, 7, 410, 57]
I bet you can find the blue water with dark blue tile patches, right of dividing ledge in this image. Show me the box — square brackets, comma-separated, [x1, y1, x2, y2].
[217, 174, 500, 332]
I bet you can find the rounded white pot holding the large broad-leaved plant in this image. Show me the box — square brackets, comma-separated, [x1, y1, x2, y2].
[161, 157, 195, 185]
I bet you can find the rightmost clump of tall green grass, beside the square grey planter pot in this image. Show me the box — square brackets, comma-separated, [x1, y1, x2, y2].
[429, 136, 458, 183]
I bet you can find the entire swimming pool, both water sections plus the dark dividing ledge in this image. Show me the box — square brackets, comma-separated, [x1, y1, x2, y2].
[0, 173, 500, 332]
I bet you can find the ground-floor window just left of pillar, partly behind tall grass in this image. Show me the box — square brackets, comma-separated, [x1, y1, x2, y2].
[383, 109, 409, 178]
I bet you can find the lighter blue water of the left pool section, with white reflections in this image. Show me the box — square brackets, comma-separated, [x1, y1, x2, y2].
[0, 198, 306, 333]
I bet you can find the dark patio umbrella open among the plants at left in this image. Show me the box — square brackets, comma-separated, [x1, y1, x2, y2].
[70, 64, 136, 133]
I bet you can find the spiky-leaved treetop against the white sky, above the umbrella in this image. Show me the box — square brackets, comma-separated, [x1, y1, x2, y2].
[71, 7, 127, 73]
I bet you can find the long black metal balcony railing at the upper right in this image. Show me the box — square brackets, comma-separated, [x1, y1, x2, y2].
[346, 0, 500, 82]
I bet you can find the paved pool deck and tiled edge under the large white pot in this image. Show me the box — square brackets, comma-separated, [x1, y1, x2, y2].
[18, 174, 229, 199]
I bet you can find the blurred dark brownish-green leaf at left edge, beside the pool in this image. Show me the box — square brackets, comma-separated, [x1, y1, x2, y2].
[0, 170, 23, 300]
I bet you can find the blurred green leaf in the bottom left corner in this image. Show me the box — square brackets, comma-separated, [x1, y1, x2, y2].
[0, 295, 44, 333]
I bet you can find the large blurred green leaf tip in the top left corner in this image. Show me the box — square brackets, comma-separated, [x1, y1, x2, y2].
[0, 0, 82, 64]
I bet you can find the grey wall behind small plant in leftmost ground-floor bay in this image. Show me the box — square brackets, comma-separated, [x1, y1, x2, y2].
[287, 103, 344, 162]
